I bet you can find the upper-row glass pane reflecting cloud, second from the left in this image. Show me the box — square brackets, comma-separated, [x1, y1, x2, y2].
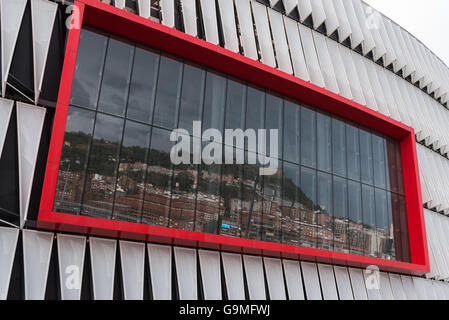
[98, 38, 135, 116]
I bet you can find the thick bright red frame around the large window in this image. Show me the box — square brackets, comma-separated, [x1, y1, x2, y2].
[37, 0, 430, 275]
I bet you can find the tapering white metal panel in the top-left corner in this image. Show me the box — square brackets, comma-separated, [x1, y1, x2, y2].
[0, 0, 27, 96]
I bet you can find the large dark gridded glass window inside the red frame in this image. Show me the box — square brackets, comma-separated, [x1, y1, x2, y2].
[54, 29, 410, 261]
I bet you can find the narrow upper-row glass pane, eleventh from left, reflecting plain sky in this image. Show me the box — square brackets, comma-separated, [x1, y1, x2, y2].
[301, 107, 316, 168]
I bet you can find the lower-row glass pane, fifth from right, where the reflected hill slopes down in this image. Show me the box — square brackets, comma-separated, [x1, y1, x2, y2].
[333, 176, 349, 253]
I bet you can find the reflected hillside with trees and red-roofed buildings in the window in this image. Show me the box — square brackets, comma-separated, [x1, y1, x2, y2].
[56, 132, 394, 256]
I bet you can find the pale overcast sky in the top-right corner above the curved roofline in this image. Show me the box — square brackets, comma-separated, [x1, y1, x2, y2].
[364, 0, 449, 66]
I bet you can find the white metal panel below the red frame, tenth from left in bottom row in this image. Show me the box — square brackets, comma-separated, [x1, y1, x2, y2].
[243, 255, 267, 300]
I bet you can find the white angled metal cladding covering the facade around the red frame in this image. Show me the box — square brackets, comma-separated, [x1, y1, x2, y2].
[0, 0, 449, 300]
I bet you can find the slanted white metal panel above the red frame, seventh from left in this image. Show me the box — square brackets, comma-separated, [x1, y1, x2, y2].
[235, 0, 258, 60]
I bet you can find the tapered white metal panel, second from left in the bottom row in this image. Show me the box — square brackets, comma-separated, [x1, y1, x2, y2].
[22, 230, 54, 300]
